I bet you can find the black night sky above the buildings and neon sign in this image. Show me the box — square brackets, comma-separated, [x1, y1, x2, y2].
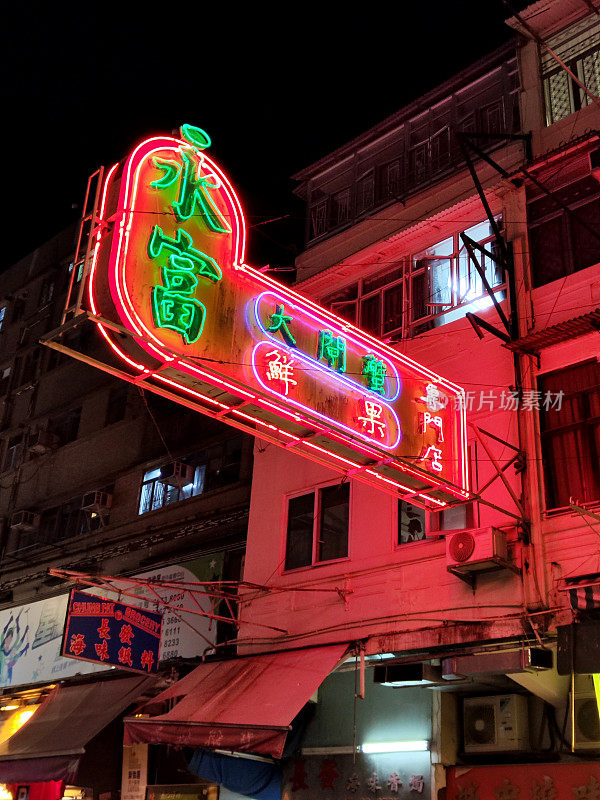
[0, 0, 525, 269]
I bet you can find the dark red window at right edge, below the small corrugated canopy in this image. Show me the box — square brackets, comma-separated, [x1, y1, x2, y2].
[539, 361, 600, 508]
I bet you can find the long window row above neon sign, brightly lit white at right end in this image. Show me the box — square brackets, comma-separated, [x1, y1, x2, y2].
[323, 217, 504, 337]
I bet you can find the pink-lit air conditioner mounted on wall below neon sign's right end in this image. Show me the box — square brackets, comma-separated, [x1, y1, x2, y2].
[446, 528, 512, 577]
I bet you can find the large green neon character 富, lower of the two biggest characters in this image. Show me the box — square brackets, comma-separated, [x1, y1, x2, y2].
[152, 256, 206, 344]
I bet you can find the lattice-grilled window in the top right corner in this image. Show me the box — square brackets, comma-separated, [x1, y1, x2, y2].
[541, 15, 600, 125]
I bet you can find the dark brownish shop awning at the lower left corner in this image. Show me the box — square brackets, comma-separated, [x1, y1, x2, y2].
[0, 676, 155, 783]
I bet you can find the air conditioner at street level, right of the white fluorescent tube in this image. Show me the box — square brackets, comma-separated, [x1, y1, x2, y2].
[463, 694, 529, 753]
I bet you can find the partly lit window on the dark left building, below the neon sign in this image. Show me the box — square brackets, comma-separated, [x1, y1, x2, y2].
[138, 436, 242, 514]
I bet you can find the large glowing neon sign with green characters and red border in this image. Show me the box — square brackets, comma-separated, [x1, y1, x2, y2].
[87, 125, 468, 506]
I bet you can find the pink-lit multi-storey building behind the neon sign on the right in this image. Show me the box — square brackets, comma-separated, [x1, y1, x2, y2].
[238, 0, 600, 800]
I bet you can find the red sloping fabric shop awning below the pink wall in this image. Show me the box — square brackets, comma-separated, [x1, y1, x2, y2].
[125, 644, 347, 758]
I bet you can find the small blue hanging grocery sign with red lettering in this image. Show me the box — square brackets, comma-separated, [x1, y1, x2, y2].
[61, 590, 162, 674]
